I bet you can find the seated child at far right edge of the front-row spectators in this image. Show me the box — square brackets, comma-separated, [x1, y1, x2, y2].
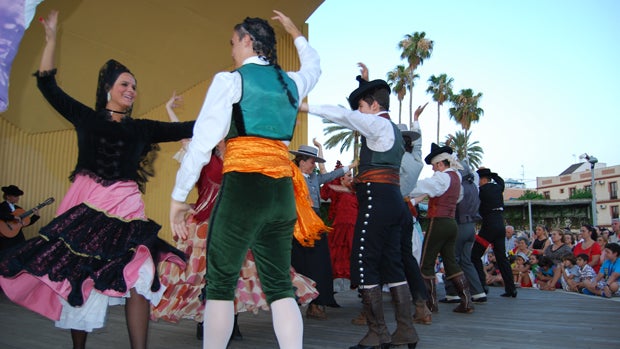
[583, 243, 620, 297]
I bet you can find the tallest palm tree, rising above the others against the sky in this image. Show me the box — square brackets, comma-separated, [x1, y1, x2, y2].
[398, 32, 433, 124]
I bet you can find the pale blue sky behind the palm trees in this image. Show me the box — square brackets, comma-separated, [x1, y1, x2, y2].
[307, 0, 620, 188]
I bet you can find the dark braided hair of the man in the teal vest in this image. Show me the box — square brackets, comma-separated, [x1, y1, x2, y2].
[235, 17, 298, 109]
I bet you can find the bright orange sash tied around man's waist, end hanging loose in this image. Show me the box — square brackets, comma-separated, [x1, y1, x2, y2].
[223, 137, 331, 247]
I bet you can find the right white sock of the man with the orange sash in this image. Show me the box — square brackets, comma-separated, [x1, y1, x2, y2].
[272, 298, 304, 349]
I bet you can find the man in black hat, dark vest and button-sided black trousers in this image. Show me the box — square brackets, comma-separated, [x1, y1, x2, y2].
[300, 72, 418, 349]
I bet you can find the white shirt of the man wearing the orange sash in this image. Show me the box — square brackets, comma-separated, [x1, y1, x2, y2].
[172, 36, 321, 201]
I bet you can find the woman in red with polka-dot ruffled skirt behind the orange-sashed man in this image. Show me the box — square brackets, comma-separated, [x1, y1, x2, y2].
[151, 94, 318, 339]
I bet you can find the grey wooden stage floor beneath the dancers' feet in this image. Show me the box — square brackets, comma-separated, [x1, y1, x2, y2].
[0, 285, 620, 349]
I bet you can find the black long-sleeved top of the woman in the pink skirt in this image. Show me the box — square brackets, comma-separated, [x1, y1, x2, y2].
[35, 70, 194, 192]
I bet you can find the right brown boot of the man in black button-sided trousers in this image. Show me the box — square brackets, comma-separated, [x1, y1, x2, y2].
[390, 284, 419, 349]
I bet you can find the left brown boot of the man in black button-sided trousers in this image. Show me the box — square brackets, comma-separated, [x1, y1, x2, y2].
[349, 286, 392, 349]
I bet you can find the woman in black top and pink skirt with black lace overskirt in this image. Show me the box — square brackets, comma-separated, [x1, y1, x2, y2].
[0, 11, 194, 348]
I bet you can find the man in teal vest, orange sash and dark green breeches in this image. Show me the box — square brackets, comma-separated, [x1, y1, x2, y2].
[170, 11, 327, 349]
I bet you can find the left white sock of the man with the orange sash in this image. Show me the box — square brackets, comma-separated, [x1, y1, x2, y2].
[202, 300, 235, 349]
